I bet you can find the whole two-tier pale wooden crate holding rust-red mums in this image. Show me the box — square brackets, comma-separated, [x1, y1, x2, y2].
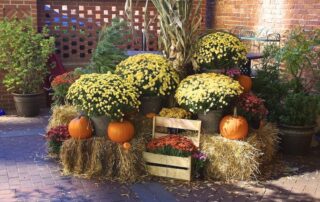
[143, 116, 201, 181]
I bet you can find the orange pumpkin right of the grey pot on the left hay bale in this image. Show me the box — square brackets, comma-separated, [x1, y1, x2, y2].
[108, 121, 134, 144]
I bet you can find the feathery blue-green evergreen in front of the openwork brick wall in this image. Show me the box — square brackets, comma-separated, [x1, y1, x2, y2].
[90, 18, 128, 73]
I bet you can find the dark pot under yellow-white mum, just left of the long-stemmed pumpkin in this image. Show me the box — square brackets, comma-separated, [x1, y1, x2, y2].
[198, 110, 222, 134]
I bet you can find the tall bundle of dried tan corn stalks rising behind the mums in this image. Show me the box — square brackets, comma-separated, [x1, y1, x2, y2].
[151, 0, 202, 75]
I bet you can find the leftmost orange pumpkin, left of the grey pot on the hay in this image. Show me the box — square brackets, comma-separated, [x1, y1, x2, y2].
[68, 116, 92, 139]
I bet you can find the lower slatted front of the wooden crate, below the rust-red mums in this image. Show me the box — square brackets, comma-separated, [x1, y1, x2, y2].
[143, 152, 192, 181]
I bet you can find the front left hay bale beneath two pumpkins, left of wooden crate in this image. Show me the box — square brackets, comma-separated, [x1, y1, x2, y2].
[60, 137, 146, 183]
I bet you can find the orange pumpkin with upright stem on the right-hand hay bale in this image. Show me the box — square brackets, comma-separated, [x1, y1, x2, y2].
[220, 108, 249, 140]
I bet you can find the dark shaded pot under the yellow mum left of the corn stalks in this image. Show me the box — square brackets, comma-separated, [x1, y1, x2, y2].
[140, 96, 162, 115]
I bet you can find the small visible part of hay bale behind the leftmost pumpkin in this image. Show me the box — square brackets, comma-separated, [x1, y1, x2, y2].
[47, 105, 78, 131]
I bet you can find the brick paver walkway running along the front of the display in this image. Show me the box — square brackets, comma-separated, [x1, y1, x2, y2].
[0, 109, 320, 202]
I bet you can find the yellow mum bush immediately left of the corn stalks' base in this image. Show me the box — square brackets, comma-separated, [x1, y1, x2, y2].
[116, 53, 179, 96]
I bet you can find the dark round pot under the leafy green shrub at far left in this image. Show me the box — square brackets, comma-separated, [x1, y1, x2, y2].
[13, 93, 43, 117]
